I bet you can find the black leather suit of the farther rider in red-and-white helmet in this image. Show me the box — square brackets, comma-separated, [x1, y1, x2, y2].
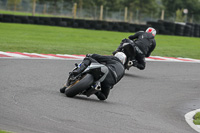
[128, 31, 156, 70]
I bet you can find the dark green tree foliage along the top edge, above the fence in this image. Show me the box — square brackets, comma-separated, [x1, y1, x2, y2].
[0, 0, 200, 21]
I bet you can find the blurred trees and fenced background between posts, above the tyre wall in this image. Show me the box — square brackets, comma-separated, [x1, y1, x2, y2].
[0, 0, 200, 23]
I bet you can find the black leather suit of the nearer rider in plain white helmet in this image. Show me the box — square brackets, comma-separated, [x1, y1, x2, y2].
[78, 54, 125, 100]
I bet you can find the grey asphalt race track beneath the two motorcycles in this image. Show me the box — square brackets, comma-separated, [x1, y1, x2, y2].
[0, 58, 200, 133]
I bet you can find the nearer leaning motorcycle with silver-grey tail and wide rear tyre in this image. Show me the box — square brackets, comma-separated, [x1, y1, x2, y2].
[60, 62, 108, 97]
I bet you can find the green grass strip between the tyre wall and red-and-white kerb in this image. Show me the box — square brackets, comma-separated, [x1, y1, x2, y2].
[0, 23, 200, 59]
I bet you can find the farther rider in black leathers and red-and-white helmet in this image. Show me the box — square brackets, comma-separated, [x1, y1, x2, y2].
[113, 27, 156, 70]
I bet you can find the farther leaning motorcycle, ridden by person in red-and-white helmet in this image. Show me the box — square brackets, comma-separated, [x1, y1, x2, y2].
[114, 39, 136, 70]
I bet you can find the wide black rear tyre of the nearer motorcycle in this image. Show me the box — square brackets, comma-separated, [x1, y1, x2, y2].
[65, 74, 94, 97]
